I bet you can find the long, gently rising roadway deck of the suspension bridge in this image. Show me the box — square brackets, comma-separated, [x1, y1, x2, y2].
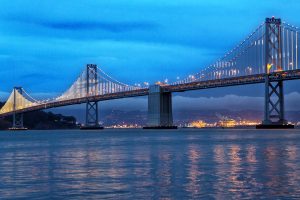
[0, 69, 300, 117]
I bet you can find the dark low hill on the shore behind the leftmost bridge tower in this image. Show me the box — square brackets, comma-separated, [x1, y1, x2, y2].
[0, 103, 78, 130]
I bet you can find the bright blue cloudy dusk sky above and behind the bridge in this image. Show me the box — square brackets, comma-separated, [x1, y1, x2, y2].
[0, 0, 300, 114]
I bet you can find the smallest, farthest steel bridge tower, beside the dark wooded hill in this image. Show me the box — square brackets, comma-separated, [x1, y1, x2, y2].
[10, 87, 26, 130]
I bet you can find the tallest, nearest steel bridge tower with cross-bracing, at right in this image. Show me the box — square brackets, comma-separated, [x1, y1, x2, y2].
[257, 17, 293, 128]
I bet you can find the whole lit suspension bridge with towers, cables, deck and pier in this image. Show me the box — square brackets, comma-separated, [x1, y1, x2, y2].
[0, 17, 300, 129]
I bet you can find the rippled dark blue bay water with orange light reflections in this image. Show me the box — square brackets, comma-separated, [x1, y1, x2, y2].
[0, 129, 300, 199]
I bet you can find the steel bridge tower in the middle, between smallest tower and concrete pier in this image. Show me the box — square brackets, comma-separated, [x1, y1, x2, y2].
[81, 64, 103, 129]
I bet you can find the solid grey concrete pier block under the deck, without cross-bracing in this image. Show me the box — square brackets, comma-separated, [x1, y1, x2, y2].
[144, 85, 177, 129]
